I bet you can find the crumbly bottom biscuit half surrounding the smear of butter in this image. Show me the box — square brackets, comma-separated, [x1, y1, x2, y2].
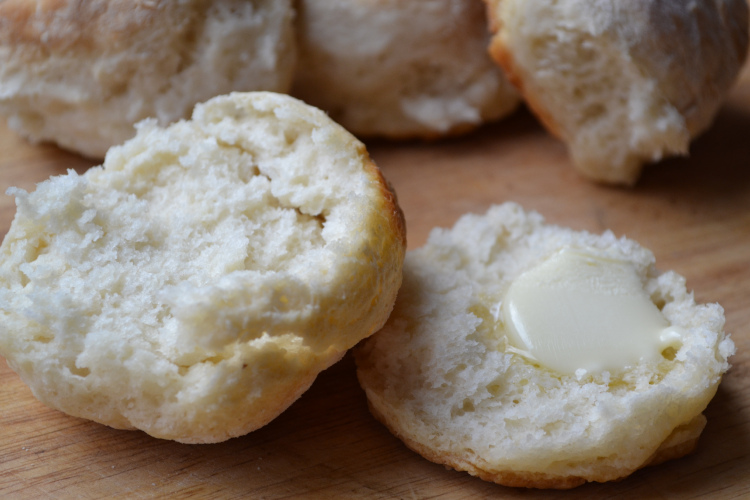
[355, 204, 734, 488]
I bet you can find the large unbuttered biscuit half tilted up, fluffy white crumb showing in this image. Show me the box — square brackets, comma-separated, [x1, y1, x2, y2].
[0, 92, 405, 443]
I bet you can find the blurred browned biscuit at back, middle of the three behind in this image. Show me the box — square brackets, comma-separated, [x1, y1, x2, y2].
[293, 0, 519, 138]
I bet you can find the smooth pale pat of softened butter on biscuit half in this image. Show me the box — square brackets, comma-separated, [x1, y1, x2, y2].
[502, 248, 682, 375]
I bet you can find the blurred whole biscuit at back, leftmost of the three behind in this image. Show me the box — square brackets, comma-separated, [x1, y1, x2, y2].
[0, 0, 296, 158]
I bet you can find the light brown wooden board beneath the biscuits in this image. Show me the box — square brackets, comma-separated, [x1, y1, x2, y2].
[0, 69, 750, 499]
